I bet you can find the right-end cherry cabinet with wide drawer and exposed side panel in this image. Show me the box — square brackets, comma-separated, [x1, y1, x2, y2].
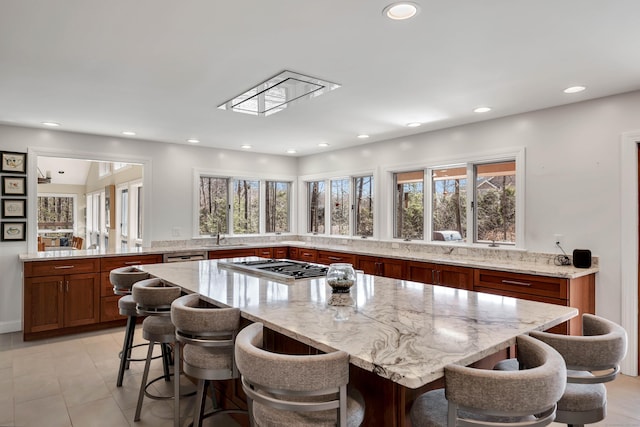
[473, 269, 595, 335]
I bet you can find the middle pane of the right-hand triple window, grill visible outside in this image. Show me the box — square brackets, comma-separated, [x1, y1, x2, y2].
[431, 166, 467, 241]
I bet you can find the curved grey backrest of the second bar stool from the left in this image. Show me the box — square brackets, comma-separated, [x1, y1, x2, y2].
[131, 278, 182, 316]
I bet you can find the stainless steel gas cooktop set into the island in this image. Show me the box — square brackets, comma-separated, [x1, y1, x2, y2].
[218, 259, 327, 282]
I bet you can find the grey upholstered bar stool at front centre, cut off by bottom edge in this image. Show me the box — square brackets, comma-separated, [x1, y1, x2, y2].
[236, 323, 365, 427]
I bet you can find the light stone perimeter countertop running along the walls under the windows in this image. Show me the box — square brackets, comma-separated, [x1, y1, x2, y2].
[19, 241, 599, 279]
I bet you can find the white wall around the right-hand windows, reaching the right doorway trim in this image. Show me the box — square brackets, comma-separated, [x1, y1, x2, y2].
[298, 92, 640, 328]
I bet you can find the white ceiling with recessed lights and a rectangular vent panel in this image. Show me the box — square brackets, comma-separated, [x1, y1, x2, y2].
[0, 0, 640, 155]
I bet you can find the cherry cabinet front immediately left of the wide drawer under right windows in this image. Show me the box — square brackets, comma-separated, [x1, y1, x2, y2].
[406, 261, 473, 290]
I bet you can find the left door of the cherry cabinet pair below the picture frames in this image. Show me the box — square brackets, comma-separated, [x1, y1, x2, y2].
[24, 276, 64, 333]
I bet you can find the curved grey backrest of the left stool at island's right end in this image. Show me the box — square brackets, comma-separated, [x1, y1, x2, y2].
[445, 335, 566, 426]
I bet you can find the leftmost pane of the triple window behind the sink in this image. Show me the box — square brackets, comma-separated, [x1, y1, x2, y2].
[199, 176, 229, 235]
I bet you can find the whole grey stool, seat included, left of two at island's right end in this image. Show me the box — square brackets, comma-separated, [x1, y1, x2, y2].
[411, 335, 566, 427]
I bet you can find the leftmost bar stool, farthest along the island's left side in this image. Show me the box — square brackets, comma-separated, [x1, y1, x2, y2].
[109, 267, 149, 387]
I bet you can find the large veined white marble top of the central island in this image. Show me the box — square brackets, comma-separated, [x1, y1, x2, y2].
[141, 258, 578, 388]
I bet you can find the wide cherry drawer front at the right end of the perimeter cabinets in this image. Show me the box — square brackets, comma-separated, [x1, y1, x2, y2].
[473, 269, 569, 300]
